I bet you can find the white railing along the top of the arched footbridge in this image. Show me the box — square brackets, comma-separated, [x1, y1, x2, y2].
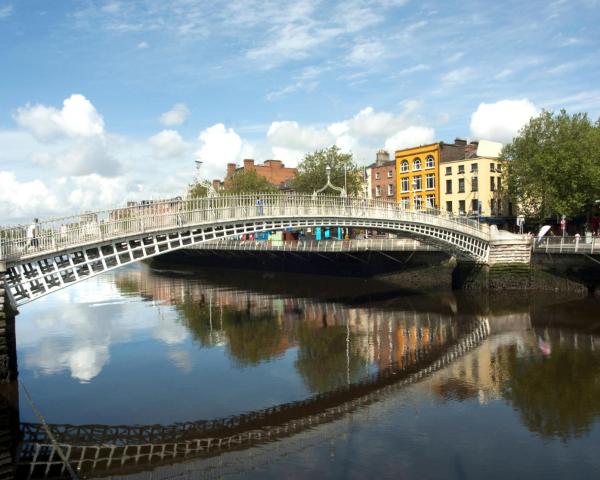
[0, 193, 487, 260]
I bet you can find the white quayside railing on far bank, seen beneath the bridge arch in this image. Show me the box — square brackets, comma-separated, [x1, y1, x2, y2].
[195, 238, 439, 252]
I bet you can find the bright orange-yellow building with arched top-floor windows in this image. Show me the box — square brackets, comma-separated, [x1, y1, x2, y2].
[395, 143, 440, 210]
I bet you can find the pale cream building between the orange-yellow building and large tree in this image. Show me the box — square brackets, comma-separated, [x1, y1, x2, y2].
[440, 140, 512, 217]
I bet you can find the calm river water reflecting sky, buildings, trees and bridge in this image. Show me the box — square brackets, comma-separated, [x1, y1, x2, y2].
[11, 265, 600, 479]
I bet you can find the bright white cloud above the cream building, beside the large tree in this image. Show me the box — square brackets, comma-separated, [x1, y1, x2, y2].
[471, 99, 538, 143]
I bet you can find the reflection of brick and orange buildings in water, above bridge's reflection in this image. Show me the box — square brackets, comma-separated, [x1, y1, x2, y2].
[117, 269, 458, 376]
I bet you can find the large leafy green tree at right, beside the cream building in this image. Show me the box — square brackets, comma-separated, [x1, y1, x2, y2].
[501, 110, 600, 221]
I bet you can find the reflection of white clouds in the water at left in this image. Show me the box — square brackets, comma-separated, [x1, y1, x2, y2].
[17, 277, 191, 382]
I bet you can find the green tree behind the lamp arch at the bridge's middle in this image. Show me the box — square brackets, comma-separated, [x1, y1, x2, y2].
[292, 145, 362, 195]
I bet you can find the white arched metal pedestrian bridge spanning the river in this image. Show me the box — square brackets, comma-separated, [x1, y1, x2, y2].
[0, 194, 490, 305]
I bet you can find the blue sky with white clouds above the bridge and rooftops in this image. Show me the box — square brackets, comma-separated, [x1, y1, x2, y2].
[0, 0, 600, 221]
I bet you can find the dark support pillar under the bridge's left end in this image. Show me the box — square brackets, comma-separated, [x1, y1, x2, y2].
[0, 260, 17, 384]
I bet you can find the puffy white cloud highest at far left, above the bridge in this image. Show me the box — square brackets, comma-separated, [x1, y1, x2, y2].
[13, 94, 104, 141]
